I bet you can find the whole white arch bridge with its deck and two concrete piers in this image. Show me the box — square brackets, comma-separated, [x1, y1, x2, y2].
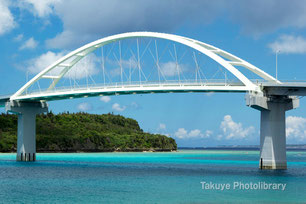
[0, 32, 306, 169]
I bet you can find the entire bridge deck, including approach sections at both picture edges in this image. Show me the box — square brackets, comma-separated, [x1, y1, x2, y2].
[0, 81, 306, 103]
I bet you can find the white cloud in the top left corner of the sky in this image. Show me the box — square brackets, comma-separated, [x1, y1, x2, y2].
[0, 0, 16, 35]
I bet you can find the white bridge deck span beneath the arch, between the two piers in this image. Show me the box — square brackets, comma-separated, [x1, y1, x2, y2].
[16, 82, 248, 101]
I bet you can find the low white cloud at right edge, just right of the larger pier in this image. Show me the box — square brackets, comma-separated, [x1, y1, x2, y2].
[286, 116, 306, 142]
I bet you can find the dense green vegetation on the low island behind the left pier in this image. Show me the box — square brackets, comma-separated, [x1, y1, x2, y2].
[0, 112, 177, 152]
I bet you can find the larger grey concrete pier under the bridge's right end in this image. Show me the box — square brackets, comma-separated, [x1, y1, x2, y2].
[246, 94, 299, 169]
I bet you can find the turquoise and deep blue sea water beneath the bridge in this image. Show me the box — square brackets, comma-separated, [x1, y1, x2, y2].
[0, 150, 306, 203]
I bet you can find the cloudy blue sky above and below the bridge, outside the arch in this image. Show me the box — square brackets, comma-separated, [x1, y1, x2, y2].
[0, 0, 306, 146]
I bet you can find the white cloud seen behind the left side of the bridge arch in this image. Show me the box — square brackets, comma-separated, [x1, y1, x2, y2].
[27, 51, 98, 79]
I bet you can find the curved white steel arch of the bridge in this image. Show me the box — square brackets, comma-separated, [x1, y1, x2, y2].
[10, 32, 280, 100]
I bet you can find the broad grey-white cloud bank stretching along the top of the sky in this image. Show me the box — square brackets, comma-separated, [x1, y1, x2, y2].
[0, 0, 306, 49]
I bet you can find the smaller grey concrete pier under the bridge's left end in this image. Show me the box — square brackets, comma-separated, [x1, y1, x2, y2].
[6, 101, 48, 161]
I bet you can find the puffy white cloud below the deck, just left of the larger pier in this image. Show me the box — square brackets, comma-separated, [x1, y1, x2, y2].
[220, 115, 255, 139]
